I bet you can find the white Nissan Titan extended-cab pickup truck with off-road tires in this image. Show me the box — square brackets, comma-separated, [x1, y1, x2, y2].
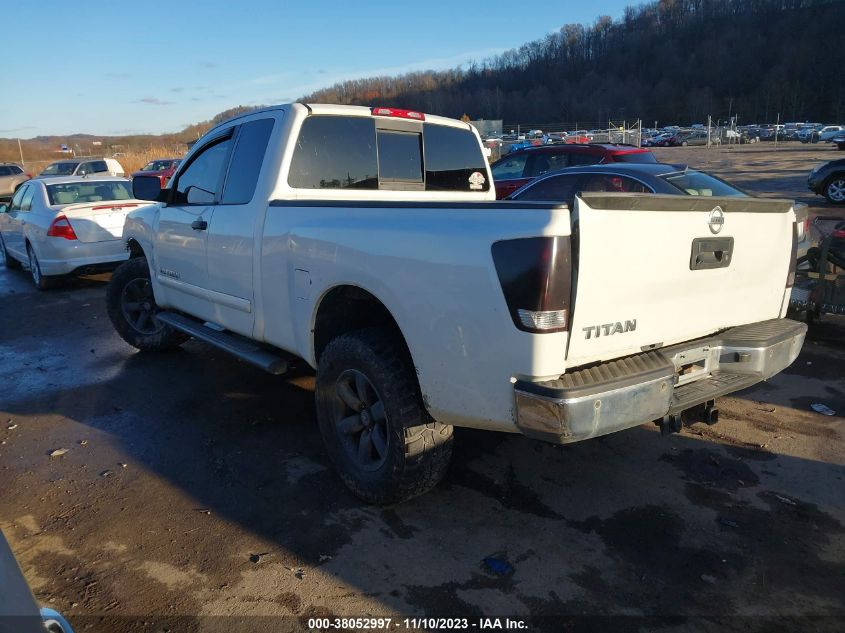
[107, 104, 806, 503]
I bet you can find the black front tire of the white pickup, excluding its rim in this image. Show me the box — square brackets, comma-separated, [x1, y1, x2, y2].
[106, 257, 190, 352]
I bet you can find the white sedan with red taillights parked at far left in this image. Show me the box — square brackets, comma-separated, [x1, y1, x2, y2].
[0, 176, 149, 290]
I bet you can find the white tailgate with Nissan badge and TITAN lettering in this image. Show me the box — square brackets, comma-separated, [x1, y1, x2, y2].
[567, 193, 795, 366]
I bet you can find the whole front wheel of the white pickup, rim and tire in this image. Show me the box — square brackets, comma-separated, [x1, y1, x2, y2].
[106, 257, 189, 352]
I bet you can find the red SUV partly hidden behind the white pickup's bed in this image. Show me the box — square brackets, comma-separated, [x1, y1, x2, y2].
[490, 143, 657, 200]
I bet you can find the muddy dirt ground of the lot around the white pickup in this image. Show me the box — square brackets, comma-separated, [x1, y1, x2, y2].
[0, 146, 845, 633]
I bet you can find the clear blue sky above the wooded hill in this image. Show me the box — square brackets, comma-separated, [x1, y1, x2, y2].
[0, 0, 637, 138]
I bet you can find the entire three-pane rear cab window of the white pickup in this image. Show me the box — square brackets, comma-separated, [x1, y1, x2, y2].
[288, 115, 490, 192]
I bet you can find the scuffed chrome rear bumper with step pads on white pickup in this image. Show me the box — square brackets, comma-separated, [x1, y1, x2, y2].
[515, 319, 807, 444]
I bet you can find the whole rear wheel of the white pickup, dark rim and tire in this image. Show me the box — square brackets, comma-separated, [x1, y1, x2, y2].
[316, 328, 452, 504]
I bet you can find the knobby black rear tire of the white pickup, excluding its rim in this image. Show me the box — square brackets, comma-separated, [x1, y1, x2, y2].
[315, 328, 453, 505]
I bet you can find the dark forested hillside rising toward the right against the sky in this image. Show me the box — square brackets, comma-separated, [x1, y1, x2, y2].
[302, 0, 845, 124]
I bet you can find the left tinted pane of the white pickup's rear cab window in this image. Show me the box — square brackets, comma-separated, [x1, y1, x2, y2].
[288, 116, 378, 189]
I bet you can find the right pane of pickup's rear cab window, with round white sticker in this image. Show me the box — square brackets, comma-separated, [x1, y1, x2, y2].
[423, 123, 490, 191]
